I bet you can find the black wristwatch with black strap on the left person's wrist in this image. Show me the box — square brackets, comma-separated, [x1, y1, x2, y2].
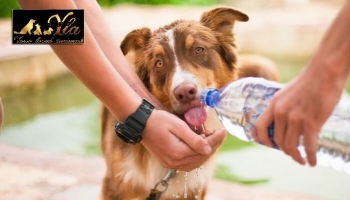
[114, 99, 154, 144]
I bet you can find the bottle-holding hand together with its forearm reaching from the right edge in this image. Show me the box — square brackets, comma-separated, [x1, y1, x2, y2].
[256, 1, 350, 166]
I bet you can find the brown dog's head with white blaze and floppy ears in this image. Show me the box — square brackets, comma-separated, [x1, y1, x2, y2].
[121, 7, 248, 123]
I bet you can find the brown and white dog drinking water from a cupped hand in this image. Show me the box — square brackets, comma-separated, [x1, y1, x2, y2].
[101, 7, 276, 200]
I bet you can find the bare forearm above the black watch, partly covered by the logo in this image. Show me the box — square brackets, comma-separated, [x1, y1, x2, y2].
[19, 0, 141, 120]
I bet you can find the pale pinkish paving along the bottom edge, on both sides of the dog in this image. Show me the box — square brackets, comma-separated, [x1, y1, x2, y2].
[0, 143, 321, 200]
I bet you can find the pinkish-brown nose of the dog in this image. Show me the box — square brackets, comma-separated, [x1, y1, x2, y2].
[173, 83, 197, 103]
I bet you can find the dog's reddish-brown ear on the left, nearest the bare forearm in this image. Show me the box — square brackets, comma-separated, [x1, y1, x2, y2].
[120, 28, 152, 55]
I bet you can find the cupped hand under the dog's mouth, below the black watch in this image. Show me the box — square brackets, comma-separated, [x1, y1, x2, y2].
[142, 110, 226, 171]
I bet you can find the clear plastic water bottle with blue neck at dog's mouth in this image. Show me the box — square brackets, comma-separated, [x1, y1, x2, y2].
[201, 77, 350, 175]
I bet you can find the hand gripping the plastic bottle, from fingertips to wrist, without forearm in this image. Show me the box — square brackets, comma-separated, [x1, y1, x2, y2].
[255, 68, 342, 166]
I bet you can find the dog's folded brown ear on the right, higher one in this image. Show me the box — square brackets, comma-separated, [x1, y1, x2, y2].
[200, 7, 249, 34]
